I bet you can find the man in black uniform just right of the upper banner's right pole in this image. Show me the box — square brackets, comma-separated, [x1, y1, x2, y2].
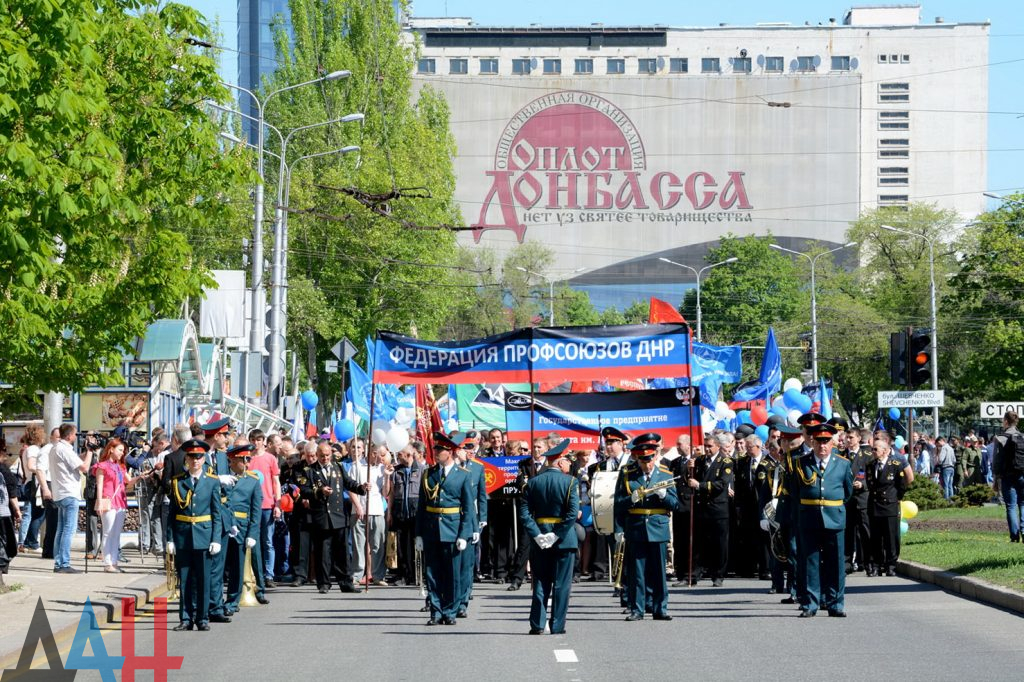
[687, 433, 735, 587]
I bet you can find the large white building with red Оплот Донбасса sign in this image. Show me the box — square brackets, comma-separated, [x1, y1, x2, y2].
[406, 5, 988, 307]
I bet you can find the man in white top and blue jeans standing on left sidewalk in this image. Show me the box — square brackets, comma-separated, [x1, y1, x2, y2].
[50, 424, 92, 573]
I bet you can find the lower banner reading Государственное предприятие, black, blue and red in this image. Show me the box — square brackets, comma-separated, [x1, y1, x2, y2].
[505, 388, 703, 450]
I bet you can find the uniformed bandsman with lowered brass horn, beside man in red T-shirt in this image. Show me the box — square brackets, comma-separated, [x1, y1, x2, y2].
[224, 441, 270, 615]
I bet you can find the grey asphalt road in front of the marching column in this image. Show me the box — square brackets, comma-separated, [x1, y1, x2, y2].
[61, 578, 1024, 682]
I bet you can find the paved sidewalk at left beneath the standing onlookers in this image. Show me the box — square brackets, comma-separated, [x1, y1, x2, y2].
[0, 534, 166, 670]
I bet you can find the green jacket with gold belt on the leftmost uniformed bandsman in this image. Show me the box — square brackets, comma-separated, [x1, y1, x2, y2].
[164, 472, 223, 552]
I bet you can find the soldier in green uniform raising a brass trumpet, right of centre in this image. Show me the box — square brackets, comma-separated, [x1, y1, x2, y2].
[614, 433, 679, 621]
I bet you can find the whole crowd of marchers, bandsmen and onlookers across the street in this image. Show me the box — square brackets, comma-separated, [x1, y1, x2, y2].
[0, 405, 1024, 634]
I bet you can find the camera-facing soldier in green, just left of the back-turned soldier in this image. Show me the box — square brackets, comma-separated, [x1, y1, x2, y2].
[415, 431, 479, 626]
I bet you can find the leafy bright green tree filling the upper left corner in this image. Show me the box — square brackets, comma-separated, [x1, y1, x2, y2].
[0, 0, 249, 409]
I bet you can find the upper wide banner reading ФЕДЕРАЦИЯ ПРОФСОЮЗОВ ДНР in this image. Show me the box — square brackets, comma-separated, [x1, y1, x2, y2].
[373, 324, 690, 384]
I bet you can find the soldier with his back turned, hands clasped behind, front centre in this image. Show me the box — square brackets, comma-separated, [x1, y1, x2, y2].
[519, 438, 580, 635]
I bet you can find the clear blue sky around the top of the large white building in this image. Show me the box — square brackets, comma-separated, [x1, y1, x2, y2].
[186, 0, 1024, 201]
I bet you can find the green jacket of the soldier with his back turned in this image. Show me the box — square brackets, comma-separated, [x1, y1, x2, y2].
[519, 468, 580, 550]
